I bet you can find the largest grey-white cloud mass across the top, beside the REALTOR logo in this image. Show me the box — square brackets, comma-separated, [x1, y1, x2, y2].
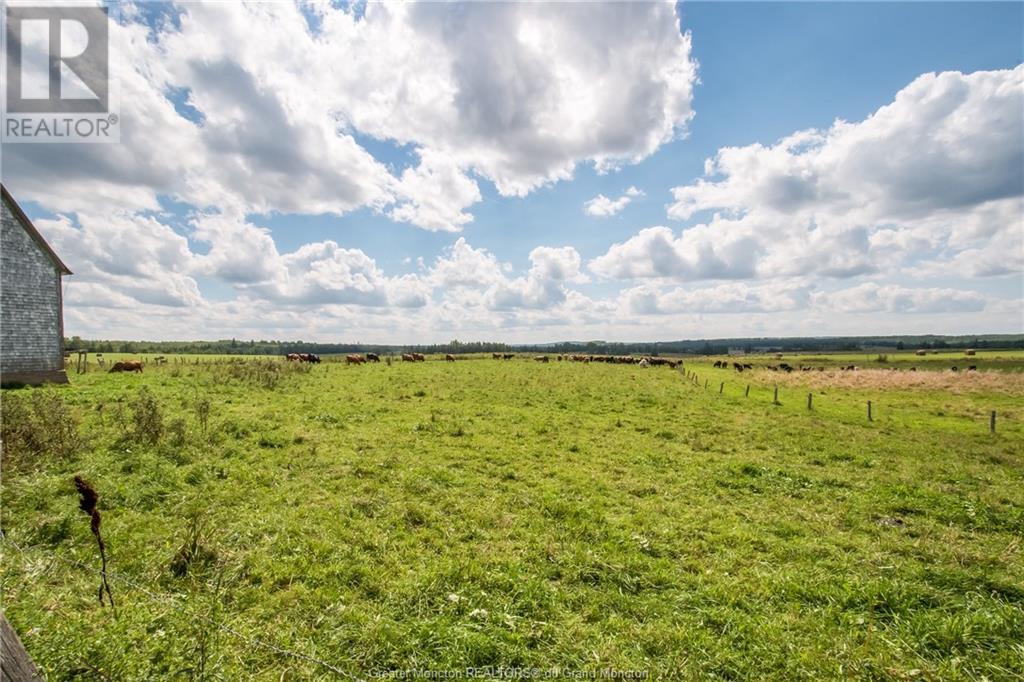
[4, 3, 696, 230]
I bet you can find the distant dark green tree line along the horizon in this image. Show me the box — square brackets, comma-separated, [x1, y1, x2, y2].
[65, 334, 1024, 355]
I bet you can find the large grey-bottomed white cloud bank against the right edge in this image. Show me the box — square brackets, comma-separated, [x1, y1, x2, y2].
[591, 66, 1024, 280]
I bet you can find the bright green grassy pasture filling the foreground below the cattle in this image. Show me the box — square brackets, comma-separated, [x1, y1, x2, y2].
[3, 356, 1024, 679]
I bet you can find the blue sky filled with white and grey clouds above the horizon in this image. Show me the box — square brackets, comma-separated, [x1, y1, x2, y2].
[0, 1, 1024, 344]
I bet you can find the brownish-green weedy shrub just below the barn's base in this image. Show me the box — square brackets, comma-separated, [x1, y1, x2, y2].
[0, 389, 85, 467]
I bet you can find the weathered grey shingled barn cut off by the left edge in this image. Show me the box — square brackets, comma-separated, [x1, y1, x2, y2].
[0, 184, 71, 386]
